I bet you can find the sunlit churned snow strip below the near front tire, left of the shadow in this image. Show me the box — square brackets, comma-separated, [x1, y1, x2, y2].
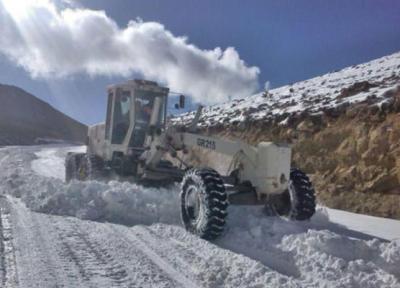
[127, 226, 297, 287]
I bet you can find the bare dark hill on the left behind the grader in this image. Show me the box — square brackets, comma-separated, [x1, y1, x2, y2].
[0, 84, 87, 146]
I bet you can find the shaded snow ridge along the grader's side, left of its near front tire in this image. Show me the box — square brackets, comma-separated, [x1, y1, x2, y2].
[25, 179, 179, 225]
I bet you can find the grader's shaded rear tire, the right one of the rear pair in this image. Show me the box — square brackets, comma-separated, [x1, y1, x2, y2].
[77, 154, 105, 181]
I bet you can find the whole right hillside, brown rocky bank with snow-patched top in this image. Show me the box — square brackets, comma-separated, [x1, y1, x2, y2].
[175, 53, 400, 219]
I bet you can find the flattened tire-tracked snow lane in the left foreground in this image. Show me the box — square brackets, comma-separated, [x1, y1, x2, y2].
[0, 190, 198, 288]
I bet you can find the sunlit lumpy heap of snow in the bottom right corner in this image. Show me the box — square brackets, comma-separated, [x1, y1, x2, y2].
[278, 230, 400, 287]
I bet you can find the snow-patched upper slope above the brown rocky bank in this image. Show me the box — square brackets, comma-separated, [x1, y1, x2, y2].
[173, 52, 400, 126]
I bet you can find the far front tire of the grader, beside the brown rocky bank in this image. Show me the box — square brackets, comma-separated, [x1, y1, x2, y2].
[267, 168, 315, 221]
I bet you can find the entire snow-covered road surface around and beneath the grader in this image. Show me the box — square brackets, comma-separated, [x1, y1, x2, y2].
[0, 146, 400, 287]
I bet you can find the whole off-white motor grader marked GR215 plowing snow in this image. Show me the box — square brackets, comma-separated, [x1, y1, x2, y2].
[66, 80, 315, 239]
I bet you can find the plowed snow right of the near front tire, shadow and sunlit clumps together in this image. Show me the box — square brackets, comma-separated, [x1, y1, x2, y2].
[217, 207, 400, 287]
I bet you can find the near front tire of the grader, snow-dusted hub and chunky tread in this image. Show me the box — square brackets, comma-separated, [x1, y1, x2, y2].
[181, 168, 228, 240]
